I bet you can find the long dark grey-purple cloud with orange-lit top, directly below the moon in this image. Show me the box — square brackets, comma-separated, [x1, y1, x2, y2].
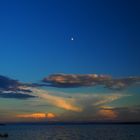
[42, 74, 111, 87]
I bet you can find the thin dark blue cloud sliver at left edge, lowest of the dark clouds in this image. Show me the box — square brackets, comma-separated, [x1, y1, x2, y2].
[0, 92, 36, 99]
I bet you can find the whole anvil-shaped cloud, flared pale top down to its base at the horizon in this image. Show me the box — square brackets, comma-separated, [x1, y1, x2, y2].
[32, 89, 130, 121]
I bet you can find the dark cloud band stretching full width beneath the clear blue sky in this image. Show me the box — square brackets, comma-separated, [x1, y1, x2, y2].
[0, 74, 140, 99]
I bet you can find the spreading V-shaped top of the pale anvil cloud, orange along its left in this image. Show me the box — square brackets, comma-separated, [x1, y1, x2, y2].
[23, 87, 127, 113]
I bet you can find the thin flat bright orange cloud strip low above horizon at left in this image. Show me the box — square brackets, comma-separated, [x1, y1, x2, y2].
[16, 113, 55, 119]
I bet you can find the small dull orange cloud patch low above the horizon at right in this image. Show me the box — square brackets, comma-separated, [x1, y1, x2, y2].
[98, 109, 117, 119]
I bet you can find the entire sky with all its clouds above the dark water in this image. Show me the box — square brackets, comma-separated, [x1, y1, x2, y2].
[0, 0, 140, 122]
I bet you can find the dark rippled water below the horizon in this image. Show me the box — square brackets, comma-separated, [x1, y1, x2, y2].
[0, 124, 140, 140]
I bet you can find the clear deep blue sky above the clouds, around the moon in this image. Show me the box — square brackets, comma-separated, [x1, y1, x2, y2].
[0, 0, 140, 81]
